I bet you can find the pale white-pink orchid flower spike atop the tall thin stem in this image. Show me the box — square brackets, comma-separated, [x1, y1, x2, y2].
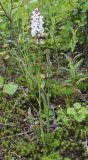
[31, 8, 44, 44]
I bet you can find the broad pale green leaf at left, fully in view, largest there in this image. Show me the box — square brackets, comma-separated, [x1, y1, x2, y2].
[3, 82, 18, 95]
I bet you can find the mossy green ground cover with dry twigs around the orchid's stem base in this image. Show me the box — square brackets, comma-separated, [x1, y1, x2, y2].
[0, 57, 88, 160]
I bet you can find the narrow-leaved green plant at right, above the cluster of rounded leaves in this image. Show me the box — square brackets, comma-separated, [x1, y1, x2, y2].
[61, 54, 88, 92]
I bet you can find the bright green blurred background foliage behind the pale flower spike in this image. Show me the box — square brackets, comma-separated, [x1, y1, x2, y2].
[1, 0, 87, 51]
